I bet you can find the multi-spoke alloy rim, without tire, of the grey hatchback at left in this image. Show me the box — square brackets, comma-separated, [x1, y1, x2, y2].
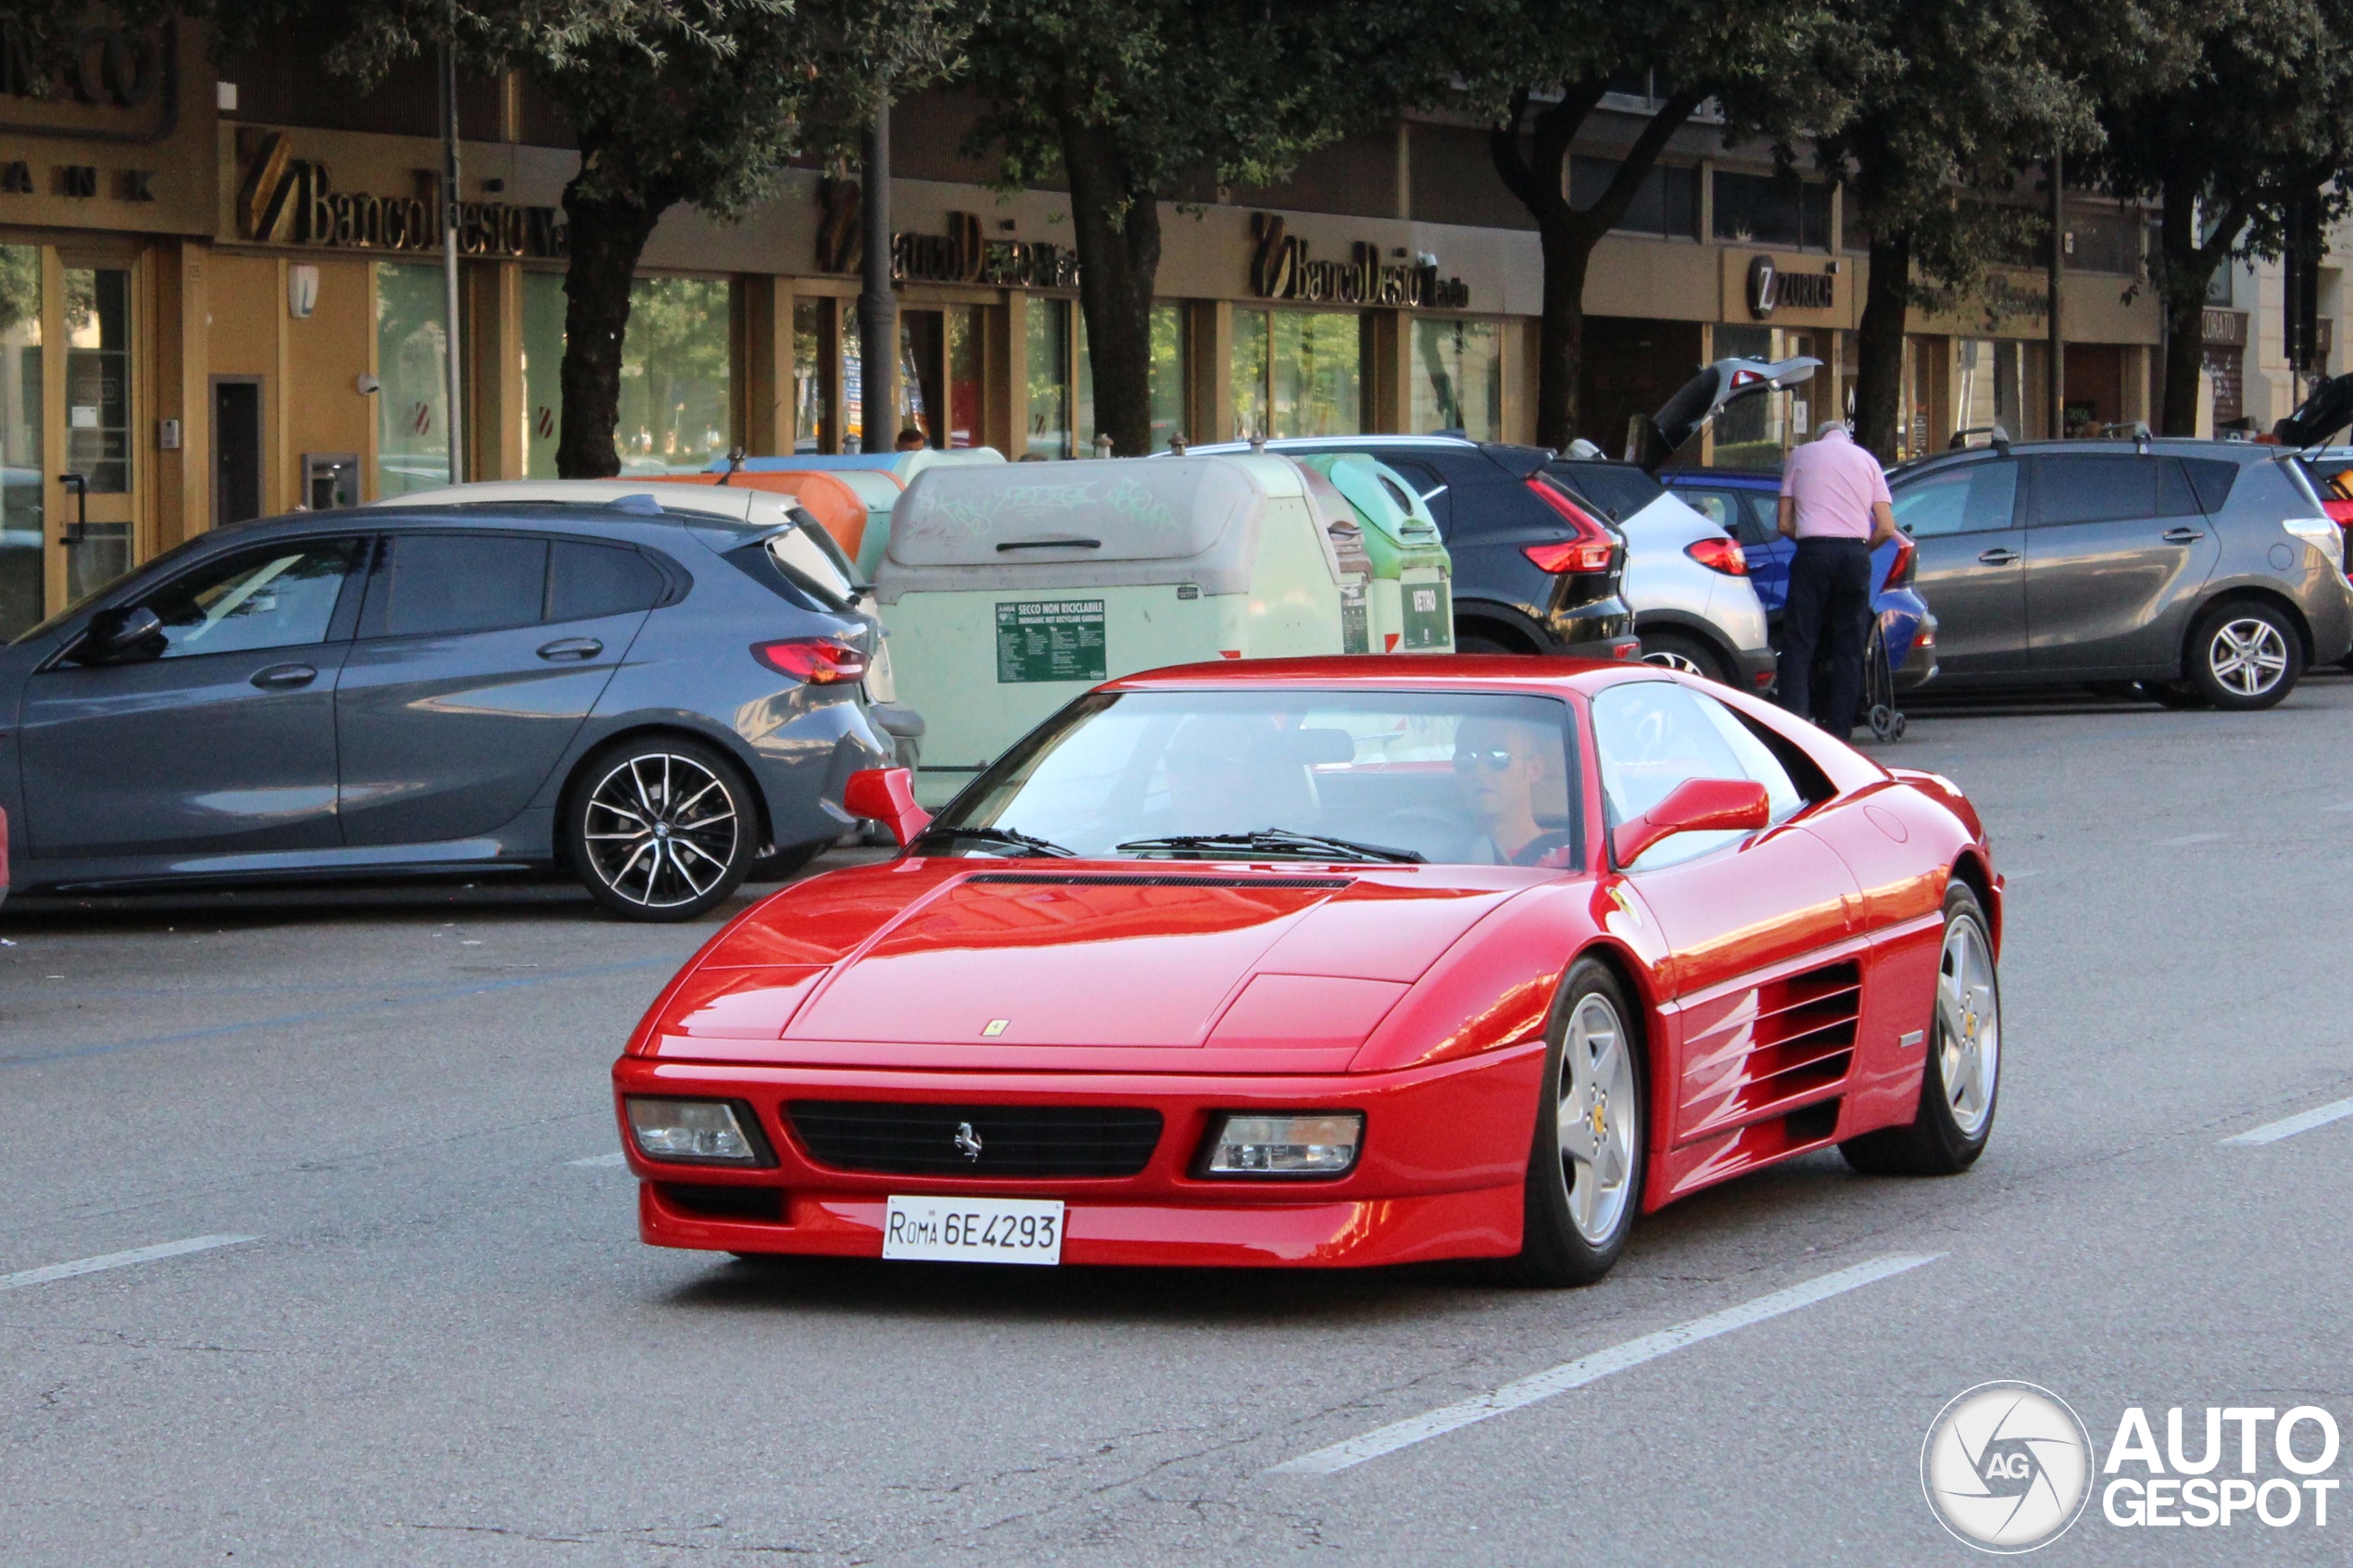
[581, 752, 741, 909]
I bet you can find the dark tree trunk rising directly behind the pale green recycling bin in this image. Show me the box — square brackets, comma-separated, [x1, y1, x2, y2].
[1062, 110, 1160, 458]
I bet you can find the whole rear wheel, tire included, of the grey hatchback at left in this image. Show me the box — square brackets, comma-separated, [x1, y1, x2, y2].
[565, 735, 760, 922]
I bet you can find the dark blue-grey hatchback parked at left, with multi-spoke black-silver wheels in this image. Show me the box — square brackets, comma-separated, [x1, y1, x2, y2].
[0, 496, 892, 919]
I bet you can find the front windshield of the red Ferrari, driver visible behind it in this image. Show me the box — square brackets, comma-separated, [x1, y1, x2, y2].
[925, 691, 1583, 870]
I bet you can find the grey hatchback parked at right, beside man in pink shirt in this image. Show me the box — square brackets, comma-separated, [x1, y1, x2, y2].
[1887, 440, 2353, 708]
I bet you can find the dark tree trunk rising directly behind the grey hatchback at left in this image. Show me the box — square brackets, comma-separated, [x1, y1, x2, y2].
[555, 176, 668, 480]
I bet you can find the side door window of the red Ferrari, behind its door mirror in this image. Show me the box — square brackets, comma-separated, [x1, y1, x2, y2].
[1593, 680, 1805, 870]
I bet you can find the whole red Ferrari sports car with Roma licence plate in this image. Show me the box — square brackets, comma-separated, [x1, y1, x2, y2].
[614, 659, 2003, 1286]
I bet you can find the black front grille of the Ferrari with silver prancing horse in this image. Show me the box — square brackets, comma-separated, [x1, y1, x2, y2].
[784, 1100, 1160, 1175]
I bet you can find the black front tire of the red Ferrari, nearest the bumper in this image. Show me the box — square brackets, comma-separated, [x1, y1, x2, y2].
[1506, 960, 1650, 1290]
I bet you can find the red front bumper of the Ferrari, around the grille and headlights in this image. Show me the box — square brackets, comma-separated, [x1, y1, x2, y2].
[614, 1041, 1543, 1267]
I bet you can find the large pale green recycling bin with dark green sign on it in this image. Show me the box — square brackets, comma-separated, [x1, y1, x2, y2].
[875, 456, 1355, 807]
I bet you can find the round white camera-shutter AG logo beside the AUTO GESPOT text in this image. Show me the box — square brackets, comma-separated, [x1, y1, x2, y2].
[1920, 1382, 2092, 1554]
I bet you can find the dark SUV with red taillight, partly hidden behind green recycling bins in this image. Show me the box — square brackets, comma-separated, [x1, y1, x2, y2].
[1190, 435, 1642, 659]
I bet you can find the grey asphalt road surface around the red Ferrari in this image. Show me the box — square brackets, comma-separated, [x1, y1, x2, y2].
[13, 674, 2353, 1568]
